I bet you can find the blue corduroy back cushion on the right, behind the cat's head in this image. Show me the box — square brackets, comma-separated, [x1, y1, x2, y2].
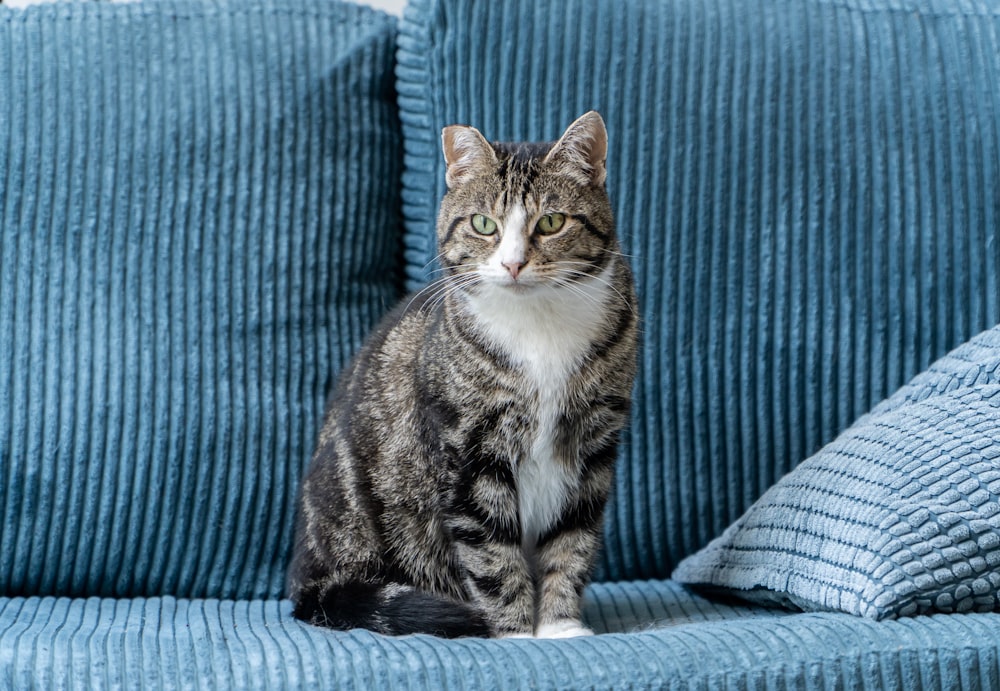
[397, 0, 1000, 579]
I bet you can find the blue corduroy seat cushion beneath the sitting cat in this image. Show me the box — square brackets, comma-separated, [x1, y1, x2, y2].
[0, 581, 1000, 689]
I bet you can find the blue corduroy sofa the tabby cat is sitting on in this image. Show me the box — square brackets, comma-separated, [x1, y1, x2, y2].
[0, 0, 1000, 689]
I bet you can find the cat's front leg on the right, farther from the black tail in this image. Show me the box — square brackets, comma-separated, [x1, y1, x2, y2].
[535, 443, 615, 638]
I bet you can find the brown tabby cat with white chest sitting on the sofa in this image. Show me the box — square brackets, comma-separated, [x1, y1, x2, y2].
[288, 111, 639, 638]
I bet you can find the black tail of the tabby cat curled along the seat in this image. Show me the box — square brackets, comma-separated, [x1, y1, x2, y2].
[292, 583, 490, 638]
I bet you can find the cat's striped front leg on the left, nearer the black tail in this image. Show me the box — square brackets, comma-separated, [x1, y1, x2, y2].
[448, 464, 534, 637]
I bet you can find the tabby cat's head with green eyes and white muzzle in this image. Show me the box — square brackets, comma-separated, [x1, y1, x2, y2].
[437, 111, 618, 292]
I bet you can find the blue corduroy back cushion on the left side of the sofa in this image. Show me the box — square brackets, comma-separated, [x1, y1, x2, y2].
[0, 0, 402, 600]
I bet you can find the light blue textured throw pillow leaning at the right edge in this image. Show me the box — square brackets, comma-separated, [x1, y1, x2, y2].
[673, 327, 1000, 619]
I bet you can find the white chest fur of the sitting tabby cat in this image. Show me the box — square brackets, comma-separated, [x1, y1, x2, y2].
[462, 268, 611, 547]
